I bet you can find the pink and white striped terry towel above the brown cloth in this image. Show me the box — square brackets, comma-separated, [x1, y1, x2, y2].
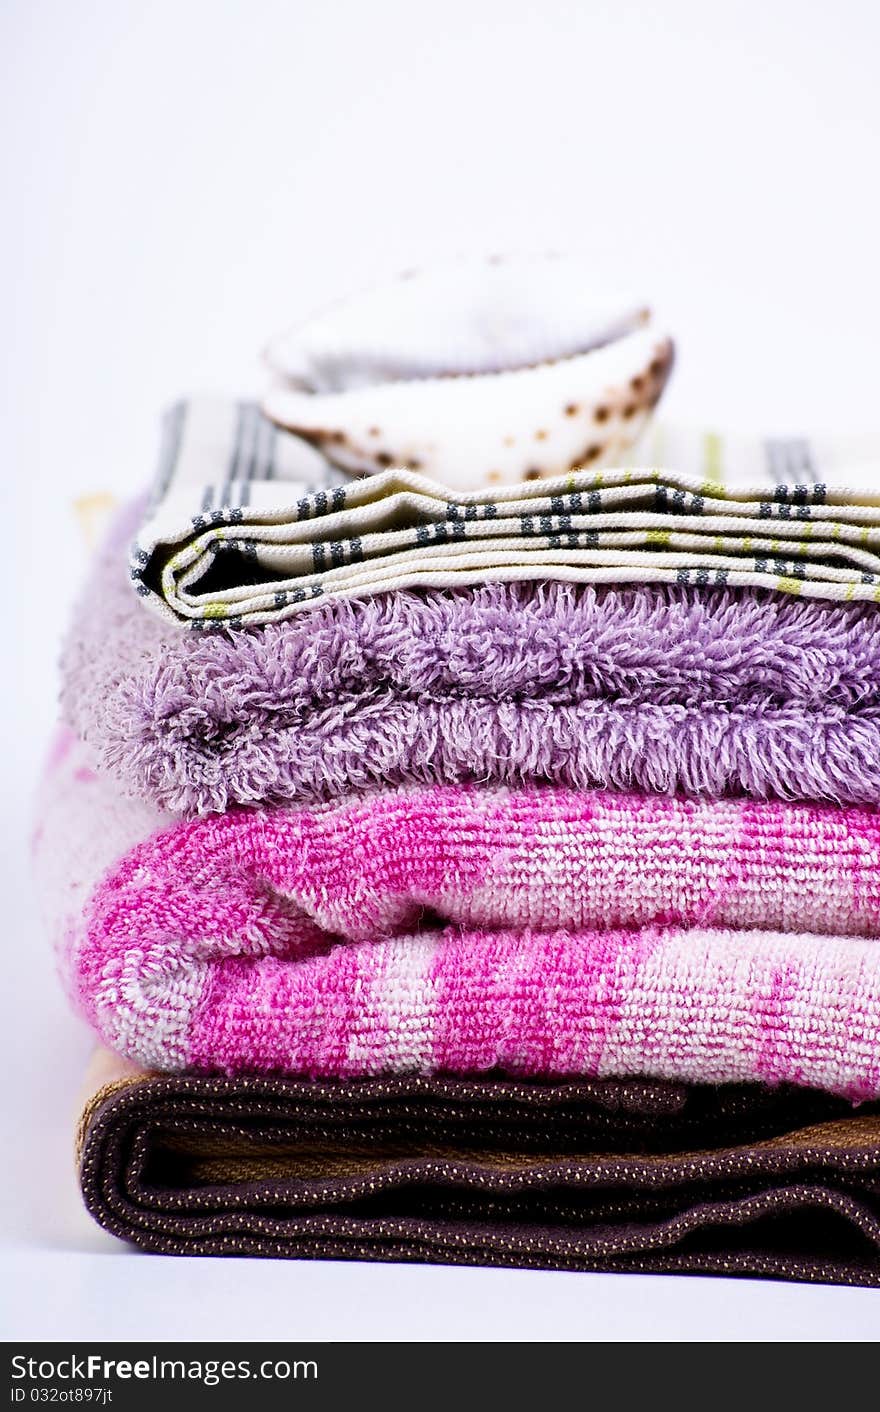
[37, 741, 880, 1099]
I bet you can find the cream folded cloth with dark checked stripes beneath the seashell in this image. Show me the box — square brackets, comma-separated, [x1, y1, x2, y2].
[130, 401, 880, 618]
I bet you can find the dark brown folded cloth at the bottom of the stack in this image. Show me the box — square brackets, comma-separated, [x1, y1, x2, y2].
[79, 1073, 880, 1285]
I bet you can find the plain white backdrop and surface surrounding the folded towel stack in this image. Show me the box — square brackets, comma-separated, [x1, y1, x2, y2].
[0, 0, 880, 1340]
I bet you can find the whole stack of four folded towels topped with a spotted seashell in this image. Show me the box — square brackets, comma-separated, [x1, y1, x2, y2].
[35, 259, 880, 1284]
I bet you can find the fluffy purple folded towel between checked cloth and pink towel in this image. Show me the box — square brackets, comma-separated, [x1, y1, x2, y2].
[64, 507, 880, 813]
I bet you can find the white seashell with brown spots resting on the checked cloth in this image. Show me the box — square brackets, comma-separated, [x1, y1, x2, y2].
[263, 257, 674, 487]
